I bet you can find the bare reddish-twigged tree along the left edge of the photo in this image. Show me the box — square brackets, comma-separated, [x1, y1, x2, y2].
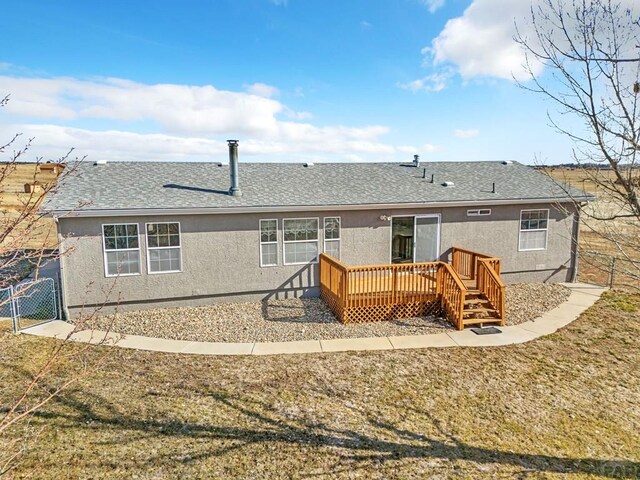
[0, 96, 115, 476]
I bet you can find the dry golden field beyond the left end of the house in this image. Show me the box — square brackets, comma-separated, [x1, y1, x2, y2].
[0, 163, 57, 248]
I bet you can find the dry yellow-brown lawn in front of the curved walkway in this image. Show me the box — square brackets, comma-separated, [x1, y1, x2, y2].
[0, 294, 640, 479]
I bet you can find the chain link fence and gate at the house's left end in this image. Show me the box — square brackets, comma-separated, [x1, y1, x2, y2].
[0, 278, 58, 333]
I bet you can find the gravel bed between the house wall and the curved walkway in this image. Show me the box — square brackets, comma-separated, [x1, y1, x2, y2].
[82, 284, 570, 342]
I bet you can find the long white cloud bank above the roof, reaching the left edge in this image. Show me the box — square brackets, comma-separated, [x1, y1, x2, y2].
[0, 75, 442, 161]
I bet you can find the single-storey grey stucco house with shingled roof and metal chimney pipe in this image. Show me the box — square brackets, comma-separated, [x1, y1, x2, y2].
[46, 141, 590, 322]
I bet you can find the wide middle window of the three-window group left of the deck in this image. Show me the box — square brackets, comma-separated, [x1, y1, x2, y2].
[282, 218, 319, 265]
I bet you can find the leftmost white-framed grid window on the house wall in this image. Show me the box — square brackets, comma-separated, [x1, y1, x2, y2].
[102, 223, 140, 277]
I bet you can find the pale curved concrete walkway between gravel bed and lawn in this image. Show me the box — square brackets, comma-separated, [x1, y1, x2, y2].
[22, 283, 605, 355]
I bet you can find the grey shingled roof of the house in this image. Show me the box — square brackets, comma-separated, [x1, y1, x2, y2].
[45, 162, 591, 215]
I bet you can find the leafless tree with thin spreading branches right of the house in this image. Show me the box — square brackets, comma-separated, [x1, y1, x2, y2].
[515, 0, 640, 286]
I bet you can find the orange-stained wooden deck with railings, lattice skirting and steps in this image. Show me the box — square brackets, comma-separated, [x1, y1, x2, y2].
[320, 248, 504, 330]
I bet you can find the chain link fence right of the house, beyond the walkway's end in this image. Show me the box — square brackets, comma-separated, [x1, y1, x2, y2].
[578, 250, 640, 290]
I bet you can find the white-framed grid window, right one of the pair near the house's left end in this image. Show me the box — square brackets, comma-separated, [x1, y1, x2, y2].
[147, 222, 182, 273]
